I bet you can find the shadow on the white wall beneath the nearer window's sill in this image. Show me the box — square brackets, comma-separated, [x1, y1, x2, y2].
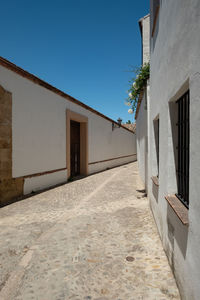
[167, 204, 188, 262]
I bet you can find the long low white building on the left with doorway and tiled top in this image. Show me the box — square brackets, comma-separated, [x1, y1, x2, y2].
[0, 58, 136, 205]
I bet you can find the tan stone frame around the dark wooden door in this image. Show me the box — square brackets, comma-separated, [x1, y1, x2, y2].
[66, 109, 88, 178]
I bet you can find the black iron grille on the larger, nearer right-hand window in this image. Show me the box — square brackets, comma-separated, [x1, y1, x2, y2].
[176, 91, 190, 208]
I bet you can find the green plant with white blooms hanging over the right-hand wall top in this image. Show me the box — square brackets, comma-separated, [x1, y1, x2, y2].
[126, 63, 150, 113]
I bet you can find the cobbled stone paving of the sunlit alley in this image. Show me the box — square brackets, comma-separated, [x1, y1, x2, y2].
[0, 163, 180, 300]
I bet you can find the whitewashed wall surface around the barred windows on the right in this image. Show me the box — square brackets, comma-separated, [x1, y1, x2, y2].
[149, 0, 200, 300]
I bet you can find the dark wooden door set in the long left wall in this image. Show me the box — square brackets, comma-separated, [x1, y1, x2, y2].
[70, 121, 80, 177]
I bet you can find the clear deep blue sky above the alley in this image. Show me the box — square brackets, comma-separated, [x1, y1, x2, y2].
[0, 0, 149, 122]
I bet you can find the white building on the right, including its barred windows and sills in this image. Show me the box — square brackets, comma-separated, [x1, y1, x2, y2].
[137, 0, 200, 300]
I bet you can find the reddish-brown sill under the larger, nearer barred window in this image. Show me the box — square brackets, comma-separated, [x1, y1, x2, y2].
[165, 195, 189, 226]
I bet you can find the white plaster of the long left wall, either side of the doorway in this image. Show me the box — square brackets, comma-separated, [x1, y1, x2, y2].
[0, 66, 136, 193]
